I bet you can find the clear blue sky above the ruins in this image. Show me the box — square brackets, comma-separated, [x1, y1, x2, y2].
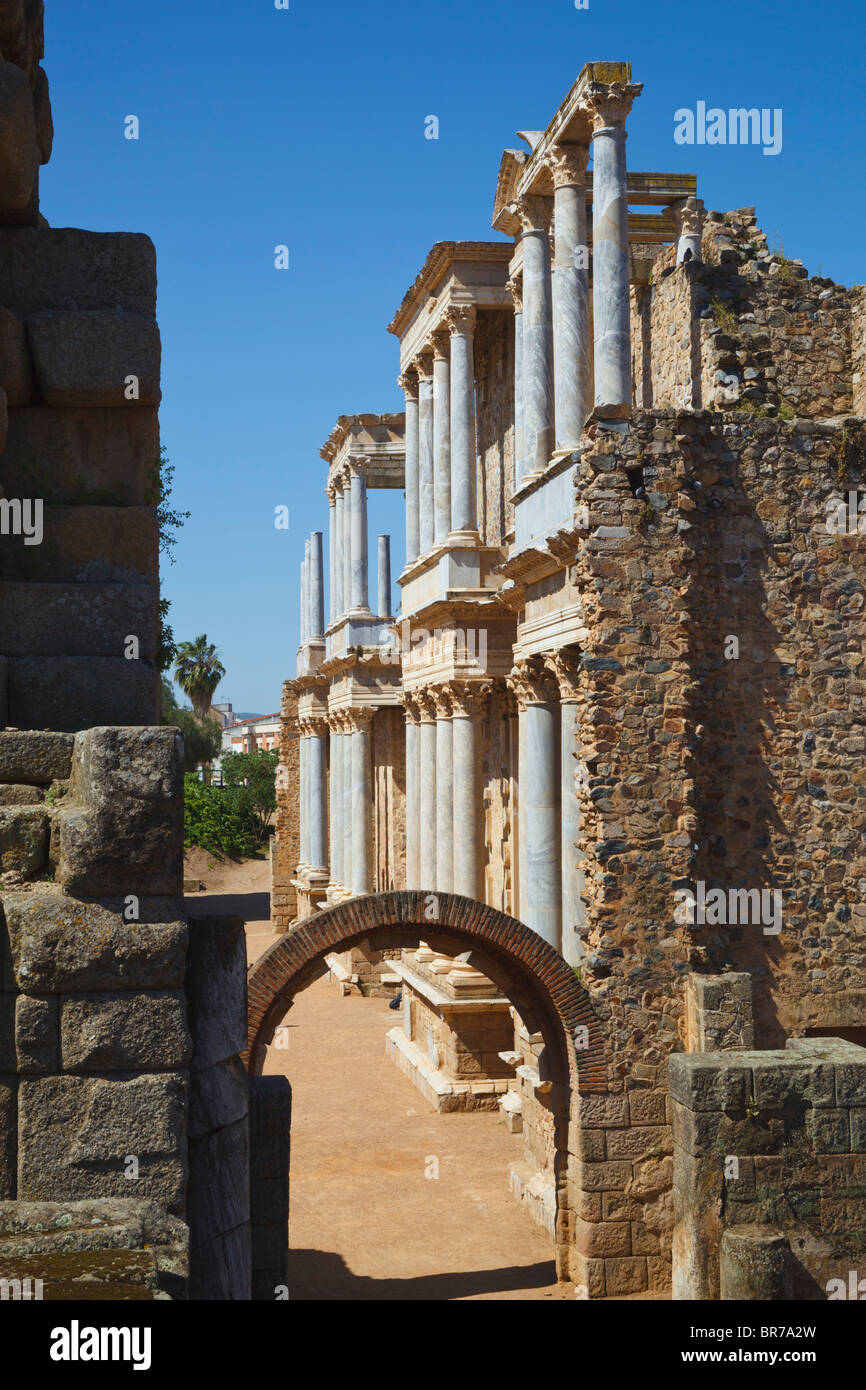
[42, 0, 866, 713]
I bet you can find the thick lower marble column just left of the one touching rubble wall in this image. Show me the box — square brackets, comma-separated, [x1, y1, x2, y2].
[512, 660, 562, 951]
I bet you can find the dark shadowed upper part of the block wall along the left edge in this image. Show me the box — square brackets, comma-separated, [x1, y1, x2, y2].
[0, 0, 160, 730]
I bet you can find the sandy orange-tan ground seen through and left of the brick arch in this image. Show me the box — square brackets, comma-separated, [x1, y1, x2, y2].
[185, 849, 574, 1301]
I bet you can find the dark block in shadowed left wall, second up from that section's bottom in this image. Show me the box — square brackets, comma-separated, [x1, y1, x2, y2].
[0, 581, 158, 662]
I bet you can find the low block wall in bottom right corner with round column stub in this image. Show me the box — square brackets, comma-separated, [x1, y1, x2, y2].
[670, 1038, 866, 1301]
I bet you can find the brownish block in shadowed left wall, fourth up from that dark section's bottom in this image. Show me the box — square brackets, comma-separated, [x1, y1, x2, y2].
[0, 405, 160, 507]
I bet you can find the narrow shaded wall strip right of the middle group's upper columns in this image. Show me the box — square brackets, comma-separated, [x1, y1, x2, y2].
[475, 313, 514, 545]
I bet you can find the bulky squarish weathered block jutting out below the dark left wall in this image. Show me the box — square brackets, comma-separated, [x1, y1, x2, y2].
[57, 728, 184, 895]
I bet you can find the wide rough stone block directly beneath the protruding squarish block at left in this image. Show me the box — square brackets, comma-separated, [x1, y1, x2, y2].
[0, 892, 188, 994]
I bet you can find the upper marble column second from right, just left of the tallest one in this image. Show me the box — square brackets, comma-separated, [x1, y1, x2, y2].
[546, 145, 591, 452]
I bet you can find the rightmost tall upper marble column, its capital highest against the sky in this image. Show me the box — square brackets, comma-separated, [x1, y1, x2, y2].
[585, 82, 642, 414]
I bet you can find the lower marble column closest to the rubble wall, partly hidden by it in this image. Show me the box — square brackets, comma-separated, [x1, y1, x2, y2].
[546, 648, 587, 966]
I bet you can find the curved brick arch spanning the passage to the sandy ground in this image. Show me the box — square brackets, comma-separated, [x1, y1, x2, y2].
[245, 891, 607, 1094]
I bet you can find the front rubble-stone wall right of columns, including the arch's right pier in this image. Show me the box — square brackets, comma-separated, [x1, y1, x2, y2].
[574, 411, 866, 1294]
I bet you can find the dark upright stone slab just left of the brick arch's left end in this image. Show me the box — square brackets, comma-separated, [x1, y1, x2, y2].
[186, 916, 247, 1072]
